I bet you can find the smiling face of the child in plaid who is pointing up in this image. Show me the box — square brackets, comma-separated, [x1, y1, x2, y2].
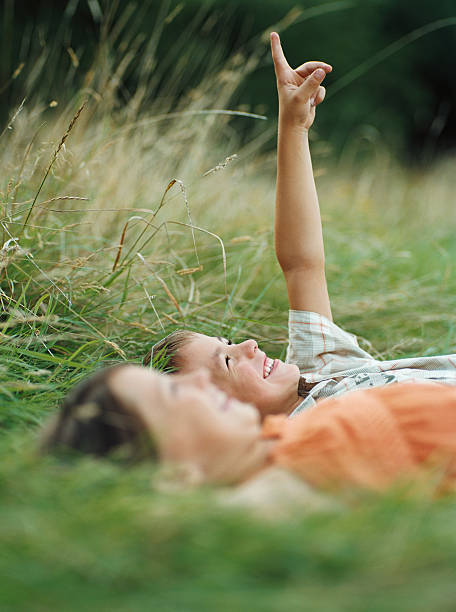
[175, 334, 302, 416]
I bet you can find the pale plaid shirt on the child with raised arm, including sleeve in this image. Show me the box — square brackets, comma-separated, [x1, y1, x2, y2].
[286, 310, 456, 416]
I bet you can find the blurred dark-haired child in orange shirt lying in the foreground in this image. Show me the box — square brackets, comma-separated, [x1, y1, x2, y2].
[43, 364, 456, 492]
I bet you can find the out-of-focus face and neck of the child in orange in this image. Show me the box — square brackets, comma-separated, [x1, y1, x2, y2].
[109, 366, 269, 483]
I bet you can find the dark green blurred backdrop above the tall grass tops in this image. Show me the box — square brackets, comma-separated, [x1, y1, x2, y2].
[0, 0, 456, 164]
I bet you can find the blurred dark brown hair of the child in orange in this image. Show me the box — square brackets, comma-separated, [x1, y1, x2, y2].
[40, 364, 157, 462]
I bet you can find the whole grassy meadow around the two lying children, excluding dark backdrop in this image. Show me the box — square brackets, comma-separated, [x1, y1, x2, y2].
[0, 13, 456, 612]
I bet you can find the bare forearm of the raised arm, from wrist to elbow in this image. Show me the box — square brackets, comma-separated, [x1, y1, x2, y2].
[275, 117, 324, 270]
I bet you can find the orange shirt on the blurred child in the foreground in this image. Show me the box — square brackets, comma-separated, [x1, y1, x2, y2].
[263, 383, 456, 490]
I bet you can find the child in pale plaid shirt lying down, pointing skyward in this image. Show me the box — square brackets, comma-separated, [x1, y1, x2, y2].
[144, 33, 456, 416]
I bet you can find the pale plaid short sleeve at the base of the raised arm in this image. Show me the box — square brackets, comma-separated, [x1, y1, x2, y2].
[286, 310, 375, 382]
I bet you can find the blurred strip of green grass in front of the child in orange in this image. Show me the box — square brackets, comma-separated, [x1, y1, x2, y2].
[0, 436, 456, 612]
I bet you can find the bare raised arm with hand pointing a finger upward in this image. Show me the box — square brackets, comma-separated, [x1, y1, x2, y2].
[271, 32, 332, 319]
